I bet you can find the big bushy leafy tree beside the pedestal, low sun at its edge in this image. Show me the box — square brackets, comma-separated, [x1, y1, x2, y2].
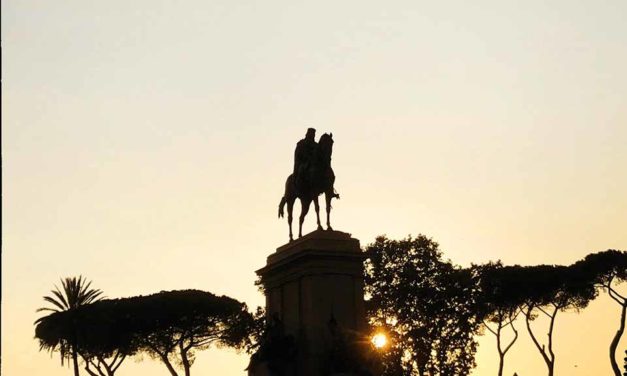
[365, 235, 479, 375]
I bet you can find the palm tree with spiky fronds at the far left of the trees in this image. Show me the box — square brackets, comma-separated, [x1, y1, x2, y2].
[35, 276, 102, 376]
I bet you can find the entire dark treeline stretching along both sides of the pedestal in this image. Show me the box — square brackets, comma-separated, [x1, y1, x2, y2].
[35, 235, 627, 376]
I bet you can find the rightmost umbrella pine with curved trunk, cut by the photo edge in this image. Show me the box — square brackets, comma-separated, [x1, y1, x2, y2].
[572, 249, 627, 376]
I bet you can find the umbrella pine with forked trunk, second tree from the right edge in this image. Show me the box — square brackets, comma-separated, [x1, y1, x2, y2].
[510, 265, 596, 376]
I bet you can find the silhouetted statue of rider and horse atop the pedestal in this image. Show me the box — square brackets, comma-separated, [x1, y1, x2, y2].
[279, 128, 340, 241]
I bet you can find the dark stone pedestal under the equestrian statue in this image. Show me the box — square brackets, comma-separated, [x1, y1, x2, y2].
[257, 230, 367, 376]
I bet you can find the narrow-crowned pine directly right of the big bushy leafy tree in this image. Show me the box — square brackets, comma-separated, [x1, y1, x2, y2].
[477, 262, 523, 376]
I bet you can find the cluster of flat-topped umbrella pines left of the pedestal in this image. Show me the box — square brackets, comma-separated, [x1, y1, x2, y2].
[35, 290, 255, 376]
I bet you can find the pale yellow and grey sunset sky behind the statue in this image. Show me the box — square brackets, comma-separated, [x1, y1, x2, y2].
[1, 0, 627, 376]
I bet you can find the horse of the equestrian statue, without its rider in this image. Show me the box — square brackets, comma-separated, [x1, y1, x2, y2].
[279, 133, 340, 241]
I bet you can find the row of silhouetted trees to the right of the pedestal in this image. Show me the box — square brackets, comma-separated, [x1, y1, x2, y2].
[365, 235, 627, 376]
